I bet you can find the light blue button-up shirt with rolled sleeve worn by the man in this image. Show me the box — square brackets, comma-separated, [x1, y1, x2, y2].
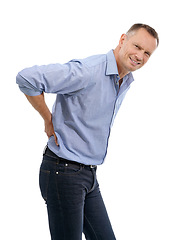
[16, 50, 134, 165]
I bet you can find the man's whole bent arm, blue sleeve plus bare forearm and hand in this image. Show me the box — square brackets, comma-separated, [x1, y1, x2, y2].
[16, 60, 91, 145]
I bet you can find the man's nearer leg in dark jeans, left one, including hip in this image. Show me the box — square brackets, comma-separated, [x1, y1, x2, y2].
[40, 155, 85, 240]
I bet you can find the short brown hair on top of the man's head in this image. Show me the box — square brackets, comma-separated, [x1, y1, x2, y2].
[127, 23, 159, 46]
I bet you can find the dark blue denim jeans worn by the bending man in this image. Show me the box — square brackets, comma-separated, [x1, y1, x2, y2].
[39, 149, 116, 240]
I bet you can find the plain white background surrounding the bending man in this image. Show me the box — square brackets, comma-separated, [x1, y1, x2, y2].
[0, 0, 176, 240]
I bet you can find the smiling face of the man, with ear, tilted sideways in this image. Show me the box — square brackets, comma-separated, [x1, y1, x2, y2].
[119, 28, 157, 72]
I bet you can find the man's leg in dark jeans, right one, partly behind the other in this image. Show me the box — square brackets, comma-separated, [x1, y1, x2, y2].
[84, 183, 116, 240]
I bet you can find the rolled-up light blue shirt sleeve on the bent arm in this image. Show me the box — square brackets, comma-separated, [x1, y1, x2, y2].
[16, 60, 90, 96]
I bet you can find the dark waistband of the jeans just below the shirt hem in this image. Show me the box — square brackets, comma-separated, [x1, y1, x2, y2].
[44, 147, 97, 170]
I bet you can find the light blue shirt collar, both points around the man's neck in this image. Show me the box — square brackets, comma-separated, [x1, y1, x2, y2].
[106, 50, 134, 83]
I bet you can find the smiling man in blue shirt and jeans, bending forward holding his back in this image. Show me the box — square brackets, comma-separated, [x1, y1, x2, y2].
[17, 24, 159, 240]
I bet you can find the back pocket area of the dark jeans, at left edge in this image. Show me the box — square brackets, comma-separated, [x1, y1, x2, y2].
[39, 169, 50, 201]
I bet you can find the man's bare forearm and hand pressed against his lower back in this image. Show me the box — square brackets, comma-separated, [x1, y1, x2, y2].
[25, 93, 59, 146]
